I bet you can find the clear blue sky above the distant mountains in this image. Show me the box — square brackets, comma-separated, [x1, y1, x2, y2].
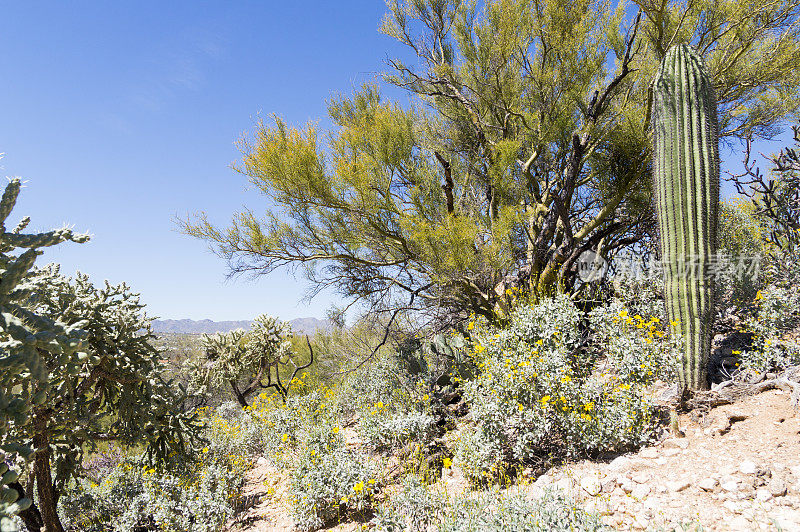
[0, 0, 792, 320]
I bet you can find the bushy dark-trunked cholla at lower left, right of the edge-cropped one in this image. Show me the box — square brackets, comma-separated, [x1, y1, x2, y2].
[6, 265, 200, 532]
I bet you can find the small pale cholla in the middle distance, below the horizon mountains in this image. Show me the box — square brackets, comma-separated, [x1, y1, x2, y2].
[186, 314, 314, 407]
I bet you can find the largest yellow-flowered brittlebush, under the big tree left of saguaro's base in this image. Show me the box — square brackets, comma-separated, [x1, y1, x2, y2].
[456, 296, 654, 484]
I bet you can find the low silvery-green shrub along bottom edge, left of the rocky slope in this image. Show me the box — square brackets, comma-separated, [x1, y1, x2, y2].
[371, 476, 603, 532]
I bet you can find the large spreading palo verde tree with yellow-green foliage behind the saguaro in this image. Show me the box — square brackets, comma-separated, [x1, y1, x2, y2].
[183, 0, 800, 326]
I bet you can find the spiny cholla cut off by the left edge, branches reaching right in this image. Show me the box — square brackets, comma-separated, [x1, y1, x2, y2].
[0, 179, 88, 530]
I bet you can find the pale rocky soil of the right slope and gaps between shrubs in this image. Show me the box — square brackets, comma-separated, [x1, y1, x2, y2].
[225, 384, 800, 531]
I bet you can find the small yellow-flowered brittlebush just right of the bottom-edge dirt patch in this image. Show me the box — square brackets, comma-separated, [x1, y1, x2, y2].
[291, 425, 379, 530]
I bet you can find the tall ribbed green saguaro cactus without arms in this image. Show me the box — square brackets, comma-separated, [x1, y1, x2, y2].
[652, 44, 719, 390]
